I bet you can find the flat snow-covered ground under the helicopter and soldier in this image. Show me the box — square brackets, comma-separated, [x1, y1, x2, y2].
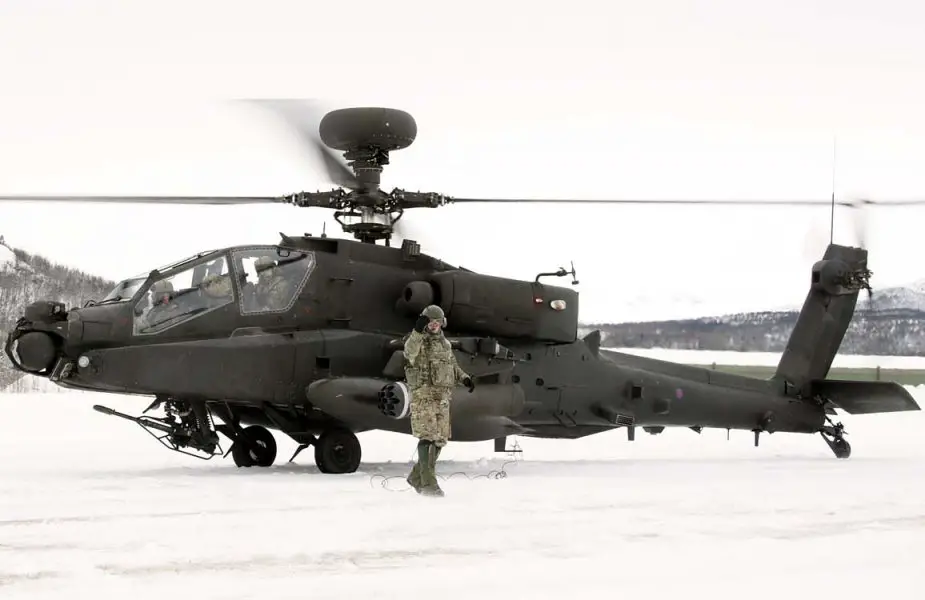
[0, 390, 925, 600]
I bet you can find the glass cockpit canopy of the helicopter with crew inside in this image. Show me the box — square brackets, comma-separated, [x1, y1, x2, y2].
[97, 246, 315, 335]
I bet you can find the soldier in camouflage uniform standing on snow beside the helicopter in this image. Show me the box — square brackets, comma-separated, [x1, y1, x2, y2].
[405, 305, 475, 496]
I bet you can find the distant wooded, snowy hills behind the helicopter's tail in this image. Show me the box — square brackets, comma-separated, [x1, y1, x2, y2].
[583, 279, 925, 356]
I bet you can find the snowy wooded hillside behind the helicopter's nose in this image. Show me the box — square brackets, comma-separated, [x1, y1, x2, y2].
[0, 236, 115, 389]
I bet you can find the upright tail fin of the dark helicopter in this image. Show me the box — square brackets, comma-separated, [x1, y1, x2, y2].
[774, 244, 870, 390]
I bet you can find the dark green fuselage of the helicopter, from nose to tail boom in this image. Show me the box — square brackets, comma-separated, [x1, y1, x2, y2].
[6, 236, 918, 468]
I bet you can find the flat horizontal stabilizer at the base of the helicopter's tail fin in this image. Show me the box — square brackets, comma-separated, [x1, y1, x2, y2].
[811, 379, 921, 415]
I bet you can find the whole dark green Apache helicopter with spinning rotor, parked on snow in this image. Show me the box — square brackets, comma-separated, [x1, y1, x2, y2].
[0, 105, 919, 473]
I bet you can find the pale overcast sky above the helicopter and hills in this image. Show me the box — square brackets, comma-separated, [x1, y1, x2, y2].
[0, 0, 925, 321]
